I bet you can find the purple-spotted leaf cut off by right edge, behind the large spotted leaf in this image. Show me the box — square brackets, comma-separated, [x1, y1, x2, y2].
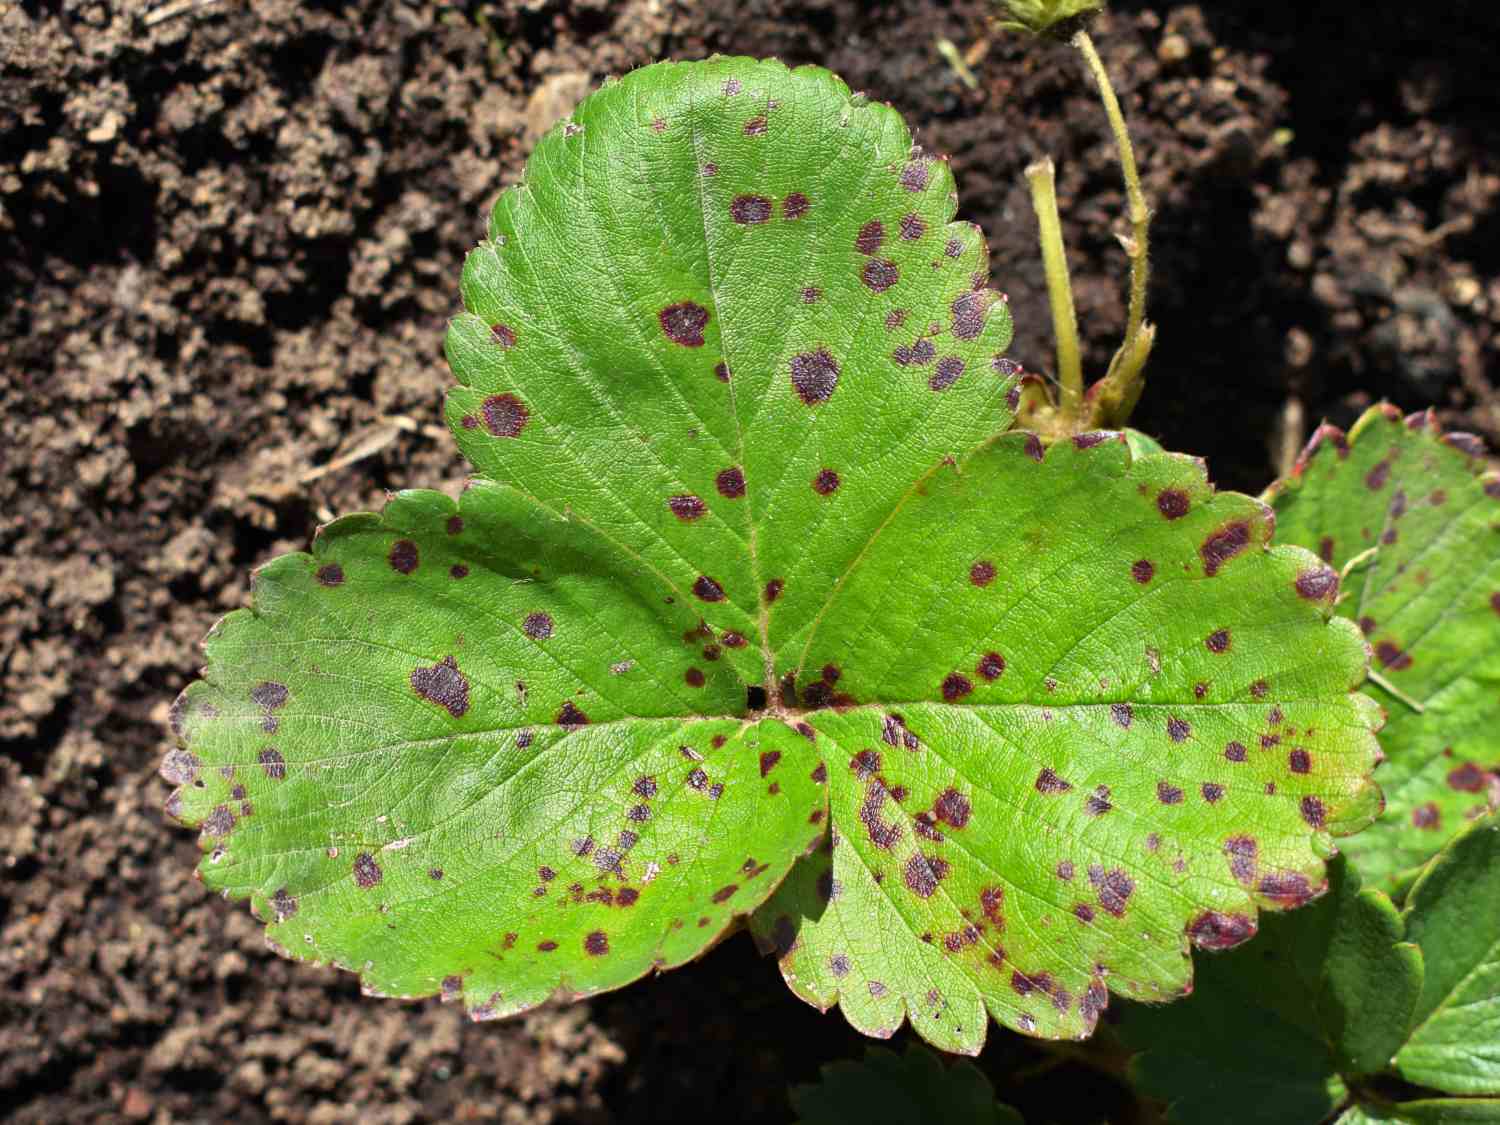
[1271, 407, 1500, 890]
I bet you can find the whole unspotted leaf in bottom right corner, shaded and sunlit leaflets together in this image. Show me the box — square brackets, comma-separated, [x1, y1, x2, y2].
[1119, 816, 1500, 1125]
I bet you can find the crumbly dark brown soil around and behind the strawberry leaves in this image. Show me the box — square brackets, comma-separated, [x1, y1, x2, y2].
[0, 0, 1500, 1125]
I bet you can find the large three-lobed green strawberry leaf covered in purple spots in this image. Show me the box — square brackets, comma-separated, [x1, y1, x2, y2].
[162, 59, 1380, 1052]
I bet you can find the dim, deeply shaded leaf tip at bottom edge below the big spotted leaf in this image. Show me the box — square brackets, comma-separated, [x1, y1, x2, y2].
[792, 1043, 1022, 1125]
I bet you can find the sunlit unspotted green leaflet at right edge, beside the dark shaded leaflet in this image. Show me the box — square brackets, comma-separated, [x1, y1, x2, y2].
[1397, 815, 1500, 1094]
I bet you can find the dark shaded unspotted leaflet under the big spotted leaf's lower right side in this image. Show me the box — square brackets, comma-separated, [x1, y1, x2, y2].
[1118, 858, 1422, 1125]
